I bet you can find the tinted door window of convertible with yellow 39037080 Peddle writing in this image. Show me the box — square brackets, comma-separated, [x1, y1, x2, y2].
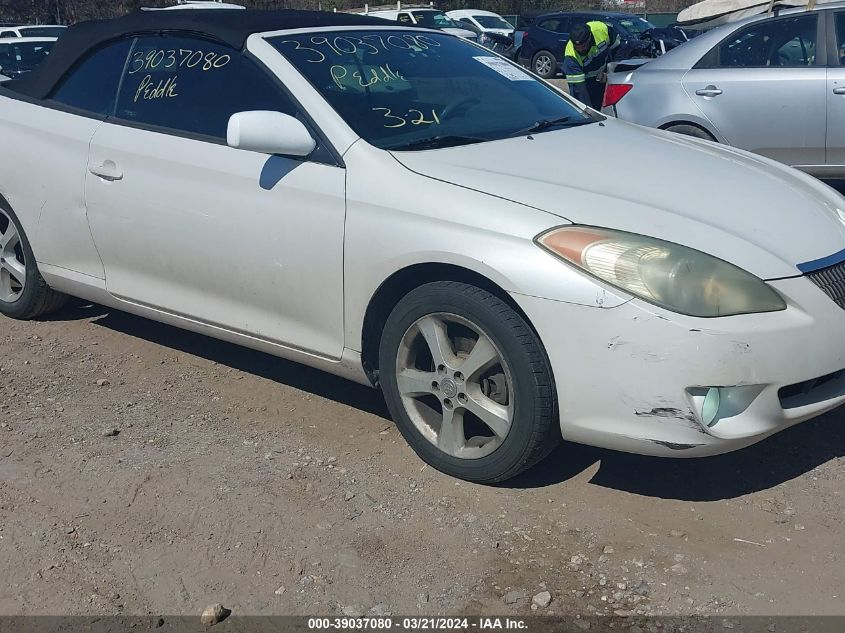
[115, 36, 296, 139]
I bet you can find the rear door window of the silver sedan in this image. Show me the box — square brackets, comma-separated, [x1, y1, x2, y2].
[718, 15, 818, 68]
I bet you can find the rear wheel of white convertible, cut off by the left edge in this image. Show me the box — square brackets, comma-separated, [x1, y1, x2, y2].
[0, 202, 67, 319]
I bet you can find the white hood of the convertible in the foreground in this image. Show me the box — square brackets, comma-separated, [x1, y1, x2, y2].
[394, 119, 845, 279]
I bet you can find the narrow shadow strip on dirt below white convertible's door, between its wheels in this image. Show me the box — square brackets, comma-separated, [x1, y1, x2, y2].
[53, 301, 391, 420]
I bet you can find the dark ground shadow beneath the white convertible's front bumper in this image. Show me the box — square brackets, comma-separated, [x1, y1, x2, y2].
[504, 407, 845, 501]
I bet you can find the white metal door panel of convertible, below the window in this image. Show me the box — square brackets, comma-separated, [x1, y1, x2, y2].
[85, 123, 345, 358]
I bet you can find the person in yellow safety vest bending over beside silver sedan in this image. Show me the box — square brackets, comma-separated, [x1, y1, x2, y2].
[563, 21, 620, 110]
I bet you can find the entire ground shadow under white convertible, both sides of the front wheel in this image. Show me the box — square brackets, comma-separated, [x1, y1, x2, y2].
[39, 300, 845, 501]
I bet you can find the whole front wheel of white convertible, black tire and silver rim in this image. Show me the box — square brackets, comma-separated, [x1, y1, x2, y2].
[379, 282, 560, 483]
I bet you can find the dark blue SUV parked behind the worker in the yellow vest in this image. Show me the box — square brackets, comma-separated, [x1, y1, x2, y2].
[519, 11, 683, 79]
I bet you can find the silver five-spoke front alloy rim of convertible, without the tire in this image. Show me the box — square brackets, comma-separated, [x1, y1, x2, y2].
[396, 313, 514, 459]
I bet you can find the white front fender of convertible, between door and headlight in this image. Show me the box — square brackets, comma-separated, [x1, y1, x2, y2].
[344, 143, 630, 345]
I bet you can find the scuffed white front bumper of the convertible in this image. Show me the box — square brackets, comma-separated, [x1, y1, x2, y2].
[513, 278, 845, 457]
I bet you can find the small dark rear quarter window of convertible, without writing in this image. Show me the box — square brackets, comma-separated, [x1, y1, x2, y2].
[51, 40, 132, 116]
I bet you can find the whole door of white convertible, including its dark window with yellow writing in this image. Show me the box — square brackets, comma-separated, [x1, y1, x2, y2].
[86, 35, 346, 359]
